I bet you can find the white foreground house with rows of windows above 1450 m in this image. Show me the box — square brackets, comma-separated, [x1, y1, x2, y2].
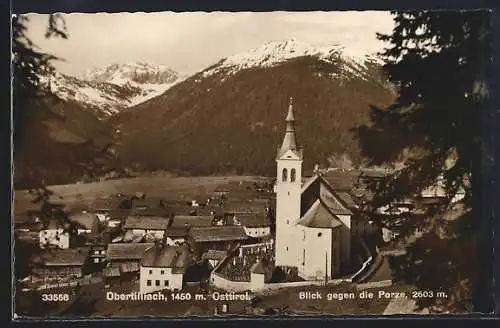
[139, 242, 192, 293]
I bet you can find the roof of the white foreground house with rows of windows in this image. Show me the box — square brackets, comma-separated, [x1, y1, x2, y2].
[141, 245, 192, 273]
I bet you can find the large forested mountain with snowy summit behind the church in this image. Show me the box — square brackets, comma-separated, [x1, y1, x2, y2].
[109, 39, 393, 174]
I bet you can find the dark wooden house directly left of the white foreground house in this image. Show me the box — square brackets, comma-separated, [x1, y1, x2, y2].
[104, 243, 154, 284]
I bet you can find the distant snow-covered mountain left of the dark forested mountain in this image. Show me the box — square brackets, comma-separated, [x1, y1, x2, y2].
[41, 63, 185, 119]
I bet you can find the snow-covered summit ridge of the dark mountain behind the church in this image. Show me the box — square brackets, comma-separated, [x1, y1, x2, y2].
[202, 38, 377, 82]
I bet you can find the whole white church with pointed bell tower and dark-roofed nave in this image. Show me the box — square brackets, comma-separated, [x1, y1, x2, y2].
[274, 98, 353, 280]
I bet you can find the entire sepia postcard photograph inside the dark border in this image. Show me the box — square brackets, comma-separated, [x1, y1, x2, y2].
[12, 10, 493, 319]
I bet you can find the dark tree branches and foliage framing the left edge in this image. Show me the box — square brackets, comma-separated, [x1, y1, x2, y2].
[12, 14, 113, 315]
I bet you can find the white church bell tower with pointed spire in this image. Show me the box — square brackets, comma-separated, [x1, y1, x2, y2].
[274, 98, 302, 267]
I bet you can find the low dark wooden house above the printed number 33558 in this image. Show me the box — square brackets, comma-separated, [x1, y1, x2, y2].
[32, 247, 89, 280]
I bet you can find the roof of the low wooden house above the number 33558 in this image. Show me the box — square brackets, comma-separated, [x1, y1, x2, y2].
[33, 247, 90, 266]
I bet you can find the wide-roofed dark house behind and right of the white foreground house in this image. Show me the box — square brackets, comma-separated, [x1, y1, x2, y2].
[188, 226, 250, 258]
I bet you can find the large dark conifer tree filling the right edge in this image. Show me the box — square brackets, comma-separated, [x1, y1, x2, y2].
[358, 11, 492, 311]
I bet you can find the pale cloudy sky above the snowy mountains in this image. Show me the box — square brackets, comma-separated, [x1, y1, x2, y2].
[23, 11, 393, 76]
